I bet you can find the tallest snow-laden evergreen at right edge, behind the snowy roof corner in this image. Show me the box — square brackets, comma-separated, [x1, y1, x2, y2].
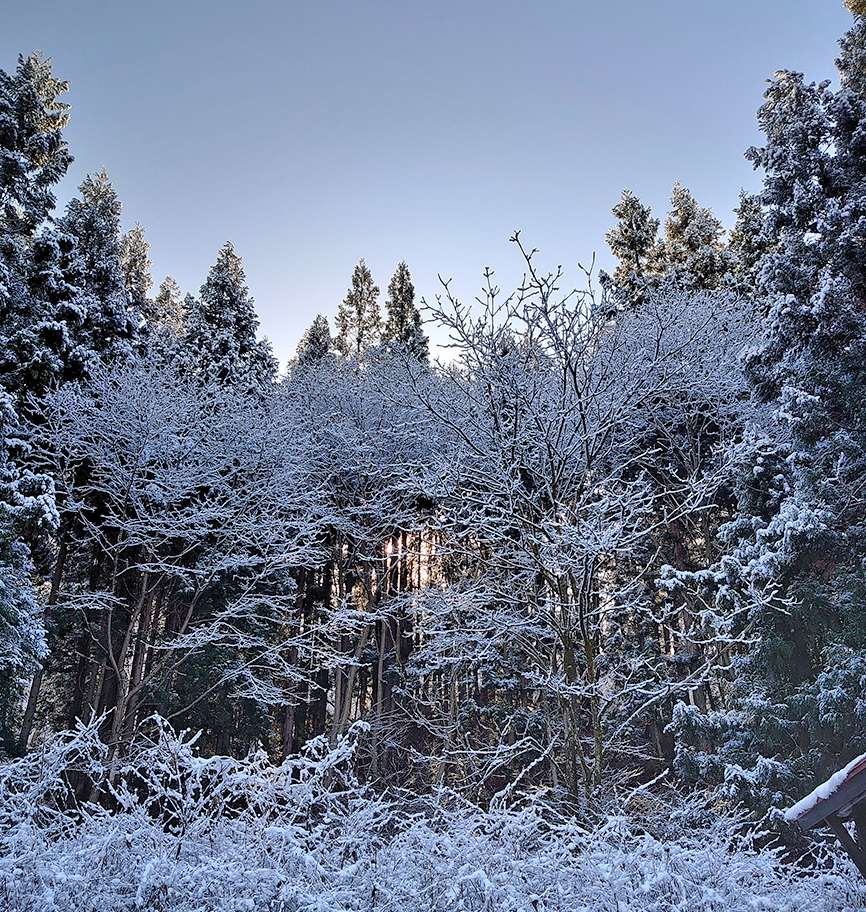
[675, 5, 866, 803]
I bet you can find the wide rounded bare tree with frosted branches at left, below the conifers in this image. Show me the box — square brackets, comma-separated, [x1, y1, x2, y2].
[27, 364, 315, 749]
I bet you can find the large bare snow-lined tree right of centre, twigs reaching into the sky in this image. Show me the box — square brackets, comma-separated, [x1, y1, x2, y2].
[408, 239, 740, 800]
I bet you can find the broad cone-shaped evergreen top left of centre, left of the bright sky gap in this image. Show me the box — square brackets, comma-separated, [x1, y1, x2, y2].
[180, 241, 277, 390]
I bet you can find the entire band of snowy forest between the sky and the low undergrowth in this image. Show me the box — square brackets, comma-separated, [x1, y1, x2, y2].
[0, 2, 866, 908]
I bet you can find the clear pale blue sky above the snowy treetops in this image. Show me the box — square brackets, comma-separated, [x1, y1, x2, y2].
[0, 0, 850, 363]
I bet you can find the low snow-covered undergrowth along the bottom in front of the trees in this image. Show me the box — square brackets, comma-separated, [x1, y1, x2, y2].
[0, 720, 866, 912]
